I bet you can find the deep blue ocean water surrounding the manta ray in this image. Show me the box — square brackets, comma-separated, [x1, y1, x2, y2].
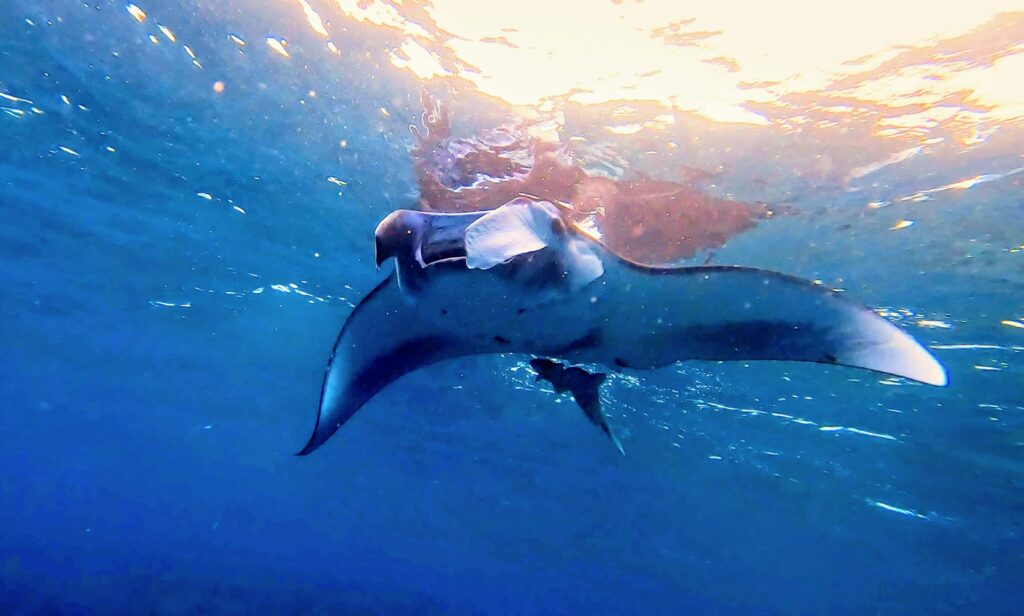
[0, 0, 1024, 614]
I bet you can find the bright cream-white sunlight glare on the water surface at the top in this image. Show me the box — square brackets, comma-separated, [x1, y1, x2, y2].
[299, 0, 1024, 132]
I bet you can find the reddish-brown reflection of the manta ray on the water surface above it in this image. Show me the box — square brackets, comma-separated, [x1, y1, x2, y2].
[411, 92, 770, 264]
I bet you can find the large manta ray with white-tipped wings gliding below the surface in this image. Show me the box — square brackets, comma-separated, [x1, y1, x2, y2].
[300, 200, 946, 454]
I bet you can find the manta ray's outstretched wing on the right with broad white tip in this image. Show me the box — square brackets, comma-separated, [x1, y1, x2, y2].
[610, 266, 947, 386]
